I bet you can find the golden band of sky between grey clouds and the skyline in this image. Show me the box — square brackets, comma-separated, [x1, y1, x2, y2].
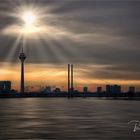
[0, 62, 140, 91]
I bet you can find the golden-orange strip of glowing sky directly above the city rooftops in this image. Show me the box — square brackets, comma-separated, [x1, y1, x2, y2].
[1, 62, 139, 91]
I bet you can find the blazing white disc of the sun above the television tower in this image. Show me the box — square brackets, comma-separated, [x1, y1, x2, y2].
[22, 11, 36, 26]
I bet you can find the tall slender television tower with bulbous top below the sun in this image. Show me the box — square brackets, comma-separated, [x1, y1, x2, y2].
[19, 46, 26, 94]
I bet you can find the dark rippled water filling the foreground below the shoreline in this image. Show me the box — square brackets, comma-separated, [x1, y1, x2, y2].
[0, 98, 140, 140]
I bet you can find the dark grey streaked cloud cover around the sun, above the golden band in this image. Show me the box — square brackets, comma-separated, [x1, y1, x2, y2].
[0, 0, 140, 80]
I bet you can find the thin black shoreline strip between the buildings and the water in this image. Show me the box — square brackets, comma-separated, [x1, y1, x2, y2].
[0, 92, 140, 100]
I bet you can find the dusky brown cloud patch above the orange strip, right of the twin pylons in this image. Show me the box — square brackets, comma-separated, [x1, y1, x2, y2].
[82, 66, 140, 80]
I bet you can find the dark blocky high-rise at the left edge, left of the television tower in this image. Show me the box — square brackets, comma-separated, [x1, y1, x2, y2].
[0, 81, 11, 93]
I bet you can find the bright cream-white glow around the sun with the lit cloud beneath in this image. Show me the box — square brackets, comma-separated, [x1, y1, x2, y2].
[2, 4, 70, 37]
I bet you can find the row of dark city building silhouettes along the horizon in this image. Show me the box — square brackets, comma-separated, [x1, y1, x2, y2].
[0, 79, 137, 93]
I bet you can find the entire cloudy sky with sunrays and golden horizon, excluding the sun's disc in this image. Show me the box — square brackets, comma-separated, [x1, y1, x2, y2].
[0, 0, 140, 90]
